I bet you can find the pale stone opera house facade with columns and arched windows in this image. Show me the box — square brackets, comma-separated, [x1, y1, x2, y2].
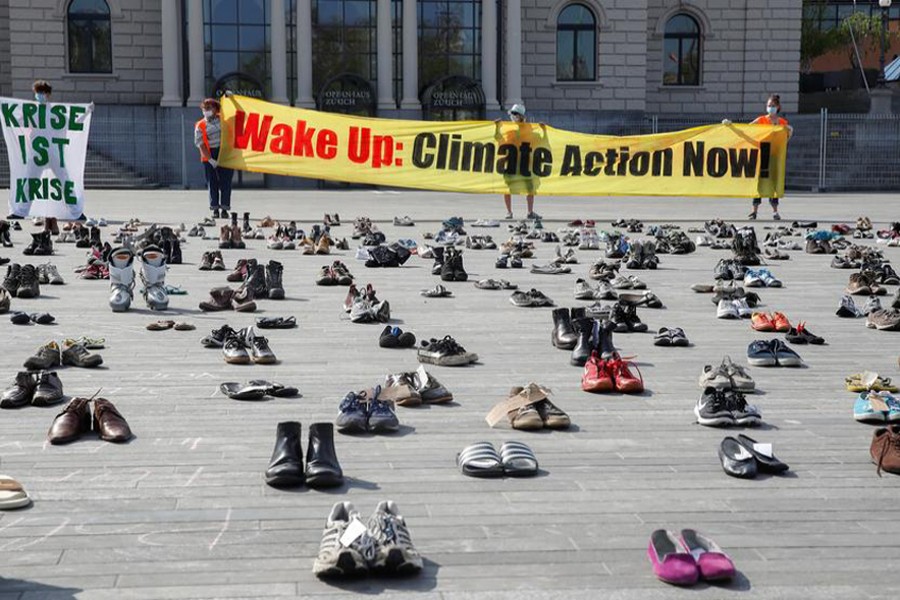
[0, 0, 801, 118]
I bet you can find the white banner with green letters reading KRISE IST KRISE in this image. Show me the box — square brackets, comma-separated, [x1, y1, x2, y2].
[0, 98, 93, 220]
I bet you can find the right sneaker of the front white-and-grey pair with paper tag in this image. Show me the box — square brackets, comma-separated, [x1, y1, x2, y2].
[366, 500, 422, 576]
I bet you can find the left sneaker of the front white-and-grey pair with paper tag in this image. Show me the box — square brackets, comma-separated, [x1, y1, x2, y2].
[313, 501, 376, 579]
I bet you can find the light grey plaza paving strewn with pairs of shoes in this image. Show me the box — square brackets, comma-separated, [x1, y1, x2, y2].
[0, 190, 900, 600]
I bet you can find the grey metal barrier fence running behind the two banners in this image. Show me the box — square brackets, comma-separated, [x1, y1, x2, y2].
[0, 106, 900, 191]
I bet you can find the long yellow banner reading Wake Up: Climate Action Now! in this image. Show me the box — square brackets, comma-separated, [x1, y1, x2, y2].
[219, 96, 787, 198]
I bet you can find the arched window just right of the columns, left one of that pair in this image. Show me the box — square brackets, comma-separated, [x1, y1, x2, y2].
[556, 4, 597, 81]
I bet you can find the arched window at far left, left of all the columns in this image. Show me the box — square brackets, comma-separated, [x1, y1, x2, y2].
[66, 0, 112, 73]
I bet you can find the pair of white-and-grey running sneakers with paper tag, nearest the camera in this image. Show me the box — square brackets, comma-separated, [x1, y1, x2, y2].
[313, 500, 422, 579]
